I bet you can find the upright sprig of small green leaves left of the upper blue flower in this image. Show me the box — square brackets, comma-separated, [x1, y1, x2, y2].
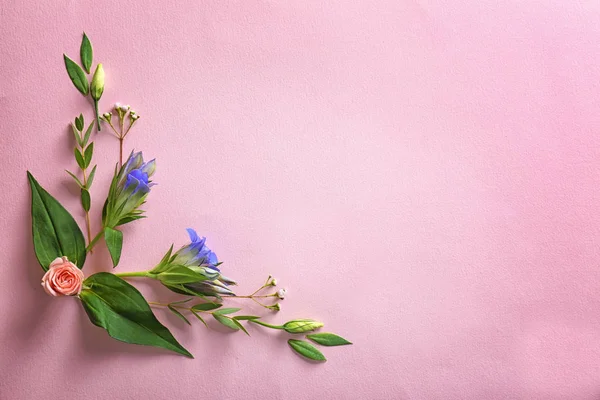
[67, 114, 96, 212]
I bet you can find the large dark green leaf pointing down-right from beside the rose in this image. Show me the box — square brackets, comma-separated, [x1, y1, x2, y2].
[79, 272, 194, 358]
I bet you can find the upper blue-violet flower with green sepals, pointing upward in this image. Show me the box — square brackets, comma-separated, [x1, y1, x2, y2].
[102, 151, 156, 228]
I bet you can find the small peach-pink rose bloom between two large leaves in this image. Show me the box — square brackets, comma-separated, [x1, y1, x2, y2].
[42, 257, 83, 296]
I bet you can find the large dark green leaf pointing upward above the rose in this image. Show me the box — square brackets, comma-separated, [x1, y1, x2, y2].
[27, 171, 85, 271]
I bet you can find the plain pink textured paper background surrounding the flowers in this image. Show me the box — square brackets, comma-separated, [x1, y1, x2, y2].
[0, 0, 600, 400]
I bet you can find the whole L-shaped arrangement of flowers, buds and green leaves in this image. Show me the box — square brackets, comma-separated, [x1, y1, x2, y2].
[27, 33, 351, 361]
